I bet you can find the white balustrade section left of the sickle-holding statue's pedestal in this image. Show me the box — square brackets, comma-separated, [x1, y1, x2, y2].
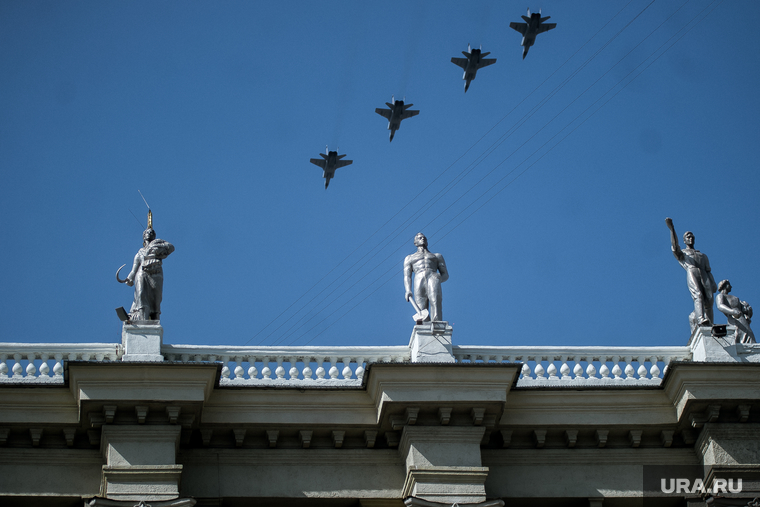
[0, 343, 124, 384]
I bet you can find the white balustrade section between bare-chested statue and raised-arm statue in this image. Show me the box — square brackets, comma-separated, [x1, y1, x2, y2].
[452, 346, 692, 387]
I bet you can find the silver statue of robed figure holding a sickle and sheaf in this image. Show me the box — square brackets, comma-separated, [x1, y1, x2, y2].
[116, 224, 174, 320]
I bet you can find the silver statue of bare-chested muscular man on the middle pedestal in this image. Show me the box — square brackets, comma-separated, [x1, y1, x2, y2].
[404, 232, 449, 321]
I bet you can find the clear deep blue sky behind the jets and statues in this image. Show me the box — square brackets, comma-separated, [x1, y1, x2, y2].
[0, 0, 760, 346]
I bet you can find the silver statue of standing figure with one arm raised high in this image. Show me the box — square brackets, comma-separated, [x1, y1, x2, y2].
[665, 218, 717, 333]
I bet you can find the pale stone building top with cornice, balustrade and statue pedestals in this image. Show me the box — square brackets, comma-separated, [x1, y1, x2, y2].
[0, 322, 760, 507]
